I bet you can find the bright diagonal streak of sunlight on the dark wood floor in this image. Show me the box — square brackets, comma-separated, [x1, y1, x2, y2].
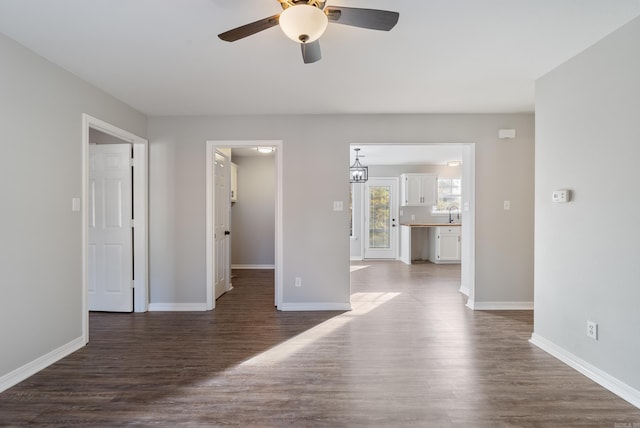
[240, 292, 400, 366]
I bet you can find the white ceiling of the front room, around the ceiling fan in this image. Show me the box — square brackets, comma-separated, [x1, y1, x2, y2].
[0, 0, 640, 115]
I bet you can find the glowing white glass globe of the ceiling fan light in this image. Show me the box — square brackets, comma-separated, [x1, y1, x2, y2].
[279, 4, 329, 43]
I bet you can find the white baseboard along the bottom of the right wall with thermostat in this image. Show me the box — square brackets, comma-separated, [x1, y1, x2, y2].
[529, 333, 640, 408]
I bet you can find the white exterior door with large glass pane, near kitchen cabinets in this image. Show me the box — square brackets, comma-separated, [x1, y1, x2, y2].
[364, 178, 398, 259]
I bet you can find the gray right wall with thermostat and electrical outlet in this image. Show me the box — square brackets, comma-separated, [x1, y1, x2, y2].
[535, 18, 640, 390]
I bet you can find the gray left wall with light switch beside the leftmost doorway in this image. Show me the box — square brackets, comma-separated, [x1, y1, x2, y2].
[0, 34, 147, 377]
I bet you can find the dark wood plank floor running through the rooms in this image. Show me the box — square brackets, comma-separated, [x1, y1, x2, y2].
[0, 262, 640, 428]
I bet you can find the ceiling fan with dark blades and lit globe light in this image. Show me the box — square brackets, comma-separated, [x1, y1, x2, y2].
[218, 0, 400, 64]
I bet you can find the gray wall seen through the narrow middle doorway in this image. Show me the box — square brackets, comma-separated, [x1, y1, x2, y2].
[231, 156, 276, 266]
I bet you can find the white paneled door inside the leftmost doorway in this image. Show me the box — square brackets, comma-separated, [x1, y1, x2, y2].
[88, 144, 133, 312]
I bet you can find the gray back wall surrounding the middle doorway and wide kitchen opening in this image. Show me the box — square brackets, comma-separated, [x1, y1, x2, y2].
[149, 114, 534, 303]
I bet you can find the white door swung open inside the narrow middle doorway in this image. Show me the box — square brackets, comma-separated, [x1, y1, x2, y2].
[213, 151, 231, 299]
